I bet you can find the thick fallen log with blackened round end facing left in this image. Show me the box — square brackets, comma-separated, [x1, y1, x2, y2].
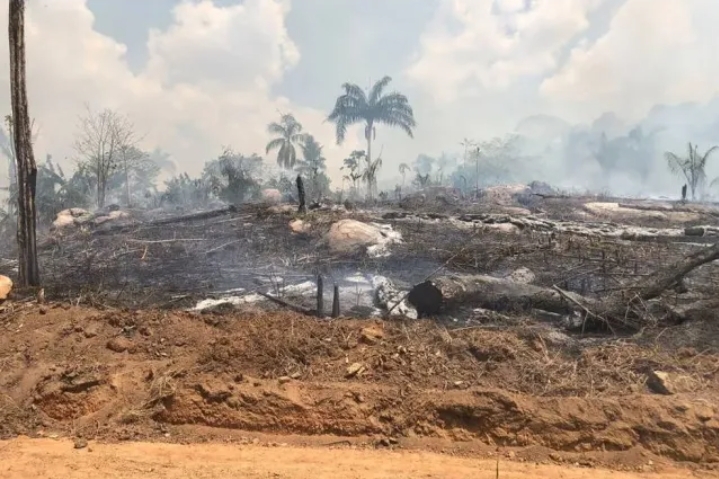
[407, 275, 586, 317]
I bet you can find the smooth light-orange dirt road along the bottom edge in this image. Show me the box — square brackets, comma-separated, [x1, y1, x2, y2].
[0, 438, 706, 479]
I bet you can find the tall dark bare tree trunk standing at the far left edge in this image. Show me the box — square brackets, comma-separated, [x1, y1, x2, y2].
[8, 0, 40, 286]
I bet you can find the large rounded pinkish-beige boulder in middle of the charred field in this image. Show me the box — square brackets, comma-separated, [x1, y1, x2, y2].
[326, 219, 402, 257]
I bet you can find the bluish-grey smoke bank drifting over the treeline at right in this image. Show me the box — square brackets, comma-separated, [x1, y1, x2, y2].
[381, 100, 719, 200]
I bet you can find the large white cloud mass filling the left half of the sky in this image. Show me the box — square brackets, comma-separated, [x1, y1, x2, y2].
[0, 0, 354, 190]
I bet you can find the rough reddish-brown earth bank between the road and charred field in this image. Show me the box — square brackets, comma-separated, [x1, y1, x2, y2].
[0, 303, 719, 477]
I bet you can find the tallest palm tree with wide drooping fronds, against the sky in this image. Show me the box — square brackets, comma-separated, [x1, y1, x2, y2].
[327, 76, 416, 193]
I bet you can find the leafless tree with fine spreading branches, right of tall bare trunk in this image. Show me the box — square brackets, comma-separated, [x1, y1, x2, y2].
[75, 107, 141, 208]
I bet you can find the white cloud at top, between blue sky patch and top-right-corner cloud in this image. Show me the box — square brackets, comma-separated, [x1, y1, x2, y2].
[407, 0, 602, 103]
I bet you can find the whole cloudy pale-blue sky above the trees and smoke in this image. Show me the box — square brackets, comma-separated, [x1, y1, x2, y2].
[0, 0, 719, 191]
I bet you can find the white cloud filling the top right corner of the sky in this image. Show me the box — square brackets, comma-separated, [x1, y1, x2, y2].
[541, 0, 719, 124]
